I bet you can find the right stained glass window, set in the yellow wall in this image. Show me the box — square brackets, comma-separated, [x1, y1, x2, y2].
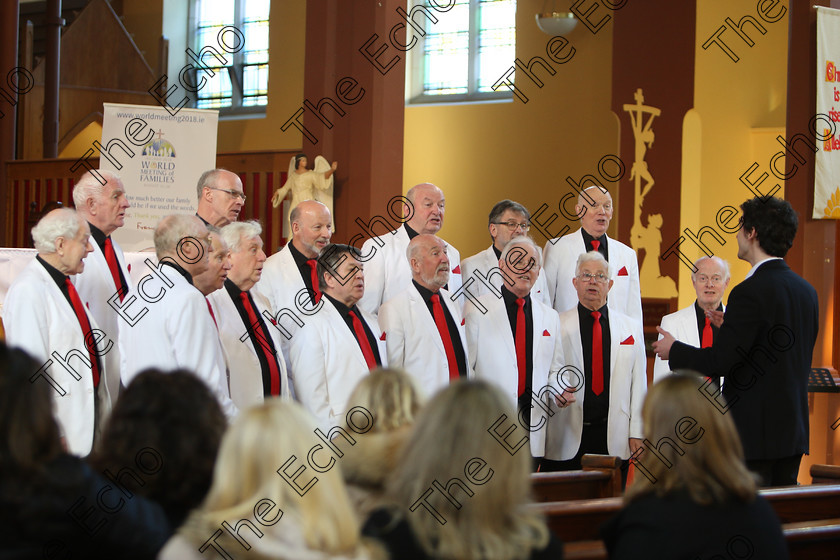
[407, 0, 516, 102]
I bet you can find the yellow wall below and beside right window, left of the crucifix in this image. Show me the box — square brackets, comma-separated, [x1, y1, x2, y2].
[403, 7, 618, 258]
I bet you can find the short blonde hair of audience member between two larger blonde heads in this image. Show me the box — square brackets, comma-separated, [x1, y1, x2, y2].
[348, 368, 420, 434]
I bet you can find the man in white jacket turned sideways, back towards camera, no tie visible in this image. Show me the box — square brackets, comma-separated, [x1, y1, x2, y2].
[120, 215, 238, 419]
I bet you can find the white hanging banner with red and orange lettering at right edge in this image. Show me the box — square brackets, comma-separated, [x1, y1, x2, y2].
[812, 7, 840, 220]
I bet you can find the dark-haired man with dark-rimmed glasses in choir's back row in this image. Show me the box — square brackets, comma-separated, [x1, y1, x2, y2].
[461, 199, 551, 306]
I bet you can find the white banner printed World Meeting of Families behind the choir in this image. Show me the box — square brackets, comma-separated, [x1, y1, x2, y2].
[99, 103, 219, 251]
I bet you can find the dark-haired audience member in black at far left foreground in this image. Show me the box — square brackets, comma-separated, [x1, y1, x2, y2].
[0, 343, 170, 559]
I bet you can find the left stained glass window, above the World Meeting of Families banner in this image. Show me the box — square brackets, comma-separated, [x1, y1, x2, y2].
[192, 0, 271, 109]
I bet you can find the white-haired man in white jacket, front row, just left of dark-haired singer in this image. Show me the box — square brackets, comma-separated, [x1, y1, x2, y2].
[207, 221, 290, 410]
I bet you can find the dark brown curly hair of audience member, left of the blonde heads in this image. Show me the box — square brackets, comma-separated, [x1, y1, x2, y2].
[90, 369, 227, 527]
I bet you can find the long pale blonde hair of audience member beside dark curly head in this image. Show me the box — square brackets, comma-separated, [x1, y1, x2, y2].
[180, 399, 360, 558]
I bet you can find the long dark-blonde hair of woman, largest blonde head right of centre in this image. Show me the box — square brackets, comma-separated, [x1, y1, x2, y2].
[386, 381, 549, 560]
